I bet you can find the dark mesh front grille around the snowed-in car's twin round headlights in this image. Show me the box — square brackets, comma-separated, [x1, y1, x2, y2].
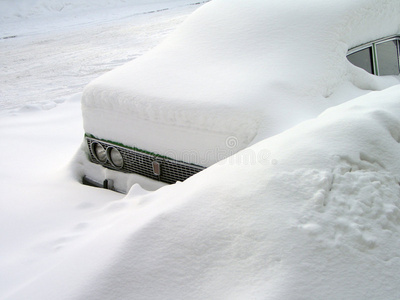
[85, 136, 205, 184]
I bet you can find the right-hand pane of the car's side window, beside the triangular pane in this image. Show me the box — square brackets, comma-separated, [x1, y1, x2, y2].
[376, 41, 399, 75]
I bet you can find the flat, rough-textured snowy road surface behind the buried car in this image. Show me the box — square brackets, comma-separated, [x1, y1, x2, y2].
[0, 0, 205, 113]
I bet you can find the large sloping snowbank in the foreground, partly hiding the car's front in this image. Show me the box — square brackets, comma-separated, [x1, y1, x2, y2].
[10, 86, 400, 300]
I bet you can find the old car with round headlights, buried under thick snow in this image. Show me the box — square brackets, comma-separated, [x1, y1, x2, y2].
[78, 0, 400, 192]
